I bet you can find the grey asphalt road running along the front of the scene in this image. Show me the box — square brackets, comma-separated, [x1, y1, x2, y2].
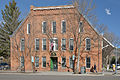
[0, 73, 120, 80]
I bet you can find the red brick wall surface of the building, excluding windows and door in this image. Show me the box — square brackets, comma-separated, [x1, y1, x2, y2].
[11, 6, 102, 72]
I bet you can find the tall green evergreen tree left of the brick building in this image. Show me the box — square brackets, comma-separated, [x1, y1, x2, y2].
[0, 0, 22, 57]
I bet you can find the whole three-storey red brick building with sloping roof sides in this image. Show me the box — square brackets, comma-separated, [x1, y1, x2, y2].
[10, 5, 102, 72]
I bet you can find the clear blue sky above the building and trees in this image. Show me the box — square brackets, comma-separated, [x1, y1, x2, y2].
[0, 0, 120, 37]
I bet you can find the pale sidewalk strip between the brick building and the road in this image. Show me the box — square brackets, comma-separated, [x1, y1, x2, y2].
[0, 71, 120, 76]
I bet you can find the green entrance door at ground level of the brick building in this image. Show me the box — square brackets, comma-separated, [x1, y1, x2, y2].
[50, 57, 58, 71]
